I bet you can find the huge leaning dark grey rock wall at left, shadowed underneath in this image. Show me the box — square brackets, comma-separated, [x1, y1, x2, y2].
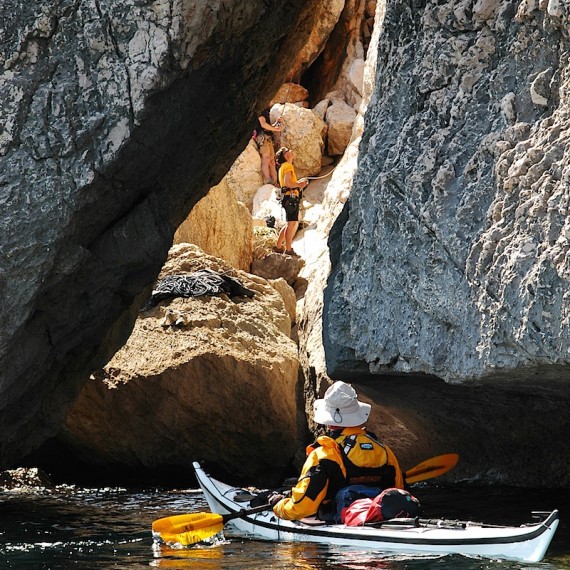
[0, 0, 318, 468]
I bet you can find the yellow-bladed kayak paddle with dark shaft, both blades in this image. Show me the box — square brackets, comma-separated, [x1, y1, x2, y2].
[152, 453, 459, 546]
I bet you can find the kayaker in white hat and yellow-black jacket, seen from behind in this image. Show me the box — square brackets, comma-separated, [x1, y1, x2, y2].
[269, 381, 404, 520]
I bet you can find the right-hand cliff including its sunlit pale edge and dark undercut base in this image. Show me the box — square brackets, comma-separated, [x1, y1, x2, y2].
[298, 3, 570, 487]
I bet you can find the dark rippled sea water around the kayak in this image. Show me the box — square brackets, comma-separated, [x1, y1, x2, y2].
[0, 483, 570, 570]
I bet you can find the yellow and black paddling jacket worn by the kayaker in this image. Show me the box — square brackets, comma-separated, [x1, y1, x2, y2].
[273, 427, 404, 520]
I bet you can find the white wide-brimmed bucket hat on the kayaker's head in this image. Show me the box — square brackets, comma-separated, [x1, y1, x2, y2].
[313, 381, 371, 427]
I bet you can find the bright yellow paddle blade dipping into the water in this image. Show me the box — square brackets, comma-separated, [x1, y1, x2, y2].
[152, 513, 224, 546]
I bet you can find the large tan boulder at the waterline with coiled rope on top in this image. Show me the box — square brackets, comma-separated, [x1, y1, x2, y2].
[59, 244, 298, 485]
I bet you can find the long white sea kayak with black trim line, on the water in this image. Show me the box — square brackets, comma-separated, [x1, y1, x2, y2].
[193, 462, 559, 562]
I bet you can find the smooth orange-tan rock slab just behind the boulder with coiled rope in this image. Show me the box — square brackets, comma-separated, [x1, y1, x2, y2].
[174, 178, 253, 271]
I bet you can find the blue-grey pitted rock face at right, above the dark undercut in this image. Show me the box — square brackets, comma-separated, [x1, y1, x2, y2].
[324, 2, 570, 382]
